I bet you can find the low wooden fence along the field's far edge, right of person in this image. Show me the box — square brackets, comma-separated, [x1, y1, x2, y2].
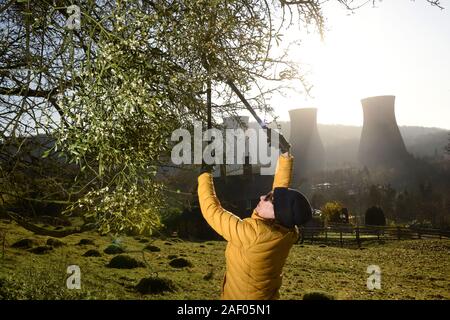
[299, 225, 450, 247]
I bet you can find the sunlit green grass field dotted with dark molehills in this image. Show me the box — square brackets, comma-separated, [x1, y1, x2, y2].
[0, 220, 450, 299]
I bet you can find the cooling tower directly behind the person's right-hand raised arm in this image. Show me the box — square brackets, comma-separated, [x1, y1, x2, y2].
[289, 108, 325, 188]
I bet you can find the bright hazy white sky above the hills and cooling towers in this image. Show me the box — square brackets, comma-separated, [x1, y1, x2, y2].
[271, 0, 450, 129]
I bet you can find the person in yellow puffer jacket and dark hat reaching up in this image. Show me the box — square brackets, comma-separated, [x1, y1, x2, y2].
[198, 152, 312, 300]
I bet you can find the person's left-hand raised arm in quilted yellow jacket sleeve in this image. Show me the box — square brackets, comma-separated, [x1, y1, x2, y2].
[198, 173, 256, 246]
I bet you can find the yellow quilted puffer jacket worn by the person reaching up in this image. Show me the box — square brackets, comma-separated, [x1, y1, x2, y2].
[198, 155, 299, 300]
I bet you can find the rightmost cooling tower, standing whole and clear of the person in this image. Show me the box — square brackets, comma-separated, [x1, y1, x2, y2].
[358, 96, 410, 167]
